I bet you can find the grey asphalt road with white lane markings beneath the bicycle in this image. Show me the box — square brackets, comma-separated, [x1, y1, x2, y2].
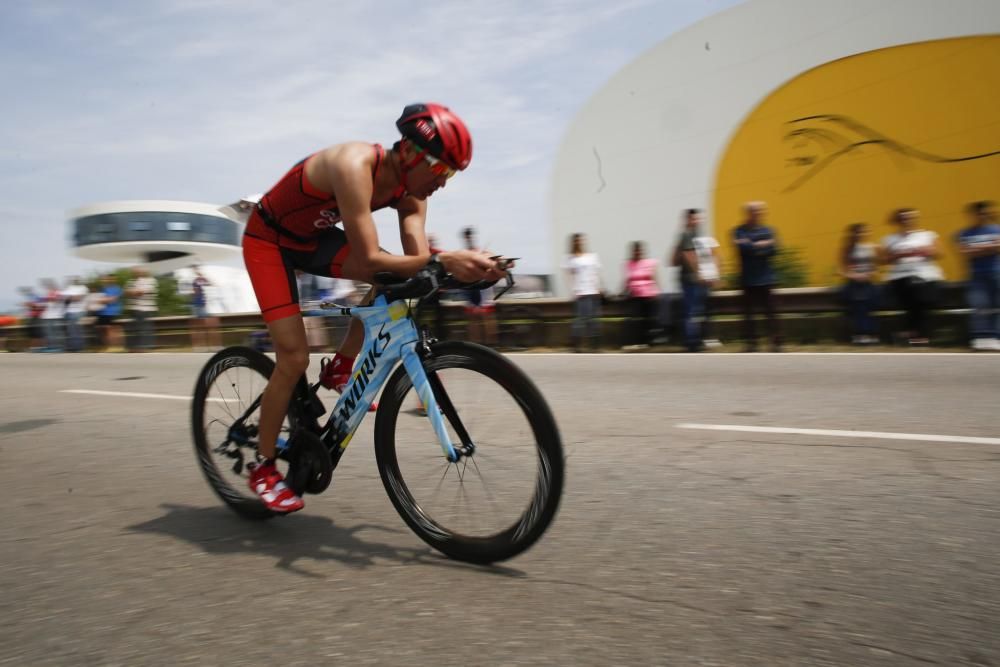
[0, 353, 1000, 667]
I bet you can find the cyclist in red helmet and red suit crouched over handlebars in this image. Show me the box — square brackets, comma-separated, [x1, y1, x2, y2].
[243, 103, 503, 512]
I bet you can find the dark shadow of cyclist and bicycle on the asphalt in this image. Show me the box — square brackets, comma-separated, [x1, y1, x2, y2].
[127, 504, 524, 578]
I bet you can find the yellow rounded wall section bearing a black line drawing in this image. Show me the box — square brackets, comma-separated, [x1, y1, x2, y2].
[713, 35, 1000, 285]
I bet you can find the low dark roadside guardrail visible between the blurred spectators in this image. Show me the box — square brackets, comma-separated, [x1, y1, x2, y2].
[0, 283, 984, 352]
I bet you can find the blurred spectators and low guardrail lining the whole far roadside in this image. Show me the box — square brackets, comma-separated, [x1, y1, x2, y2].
[0, 201, 1000, 352]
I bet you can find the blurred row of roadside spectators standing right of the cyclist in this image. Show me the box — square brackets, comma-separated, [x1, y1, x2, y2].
[562, 200, 1000, 352]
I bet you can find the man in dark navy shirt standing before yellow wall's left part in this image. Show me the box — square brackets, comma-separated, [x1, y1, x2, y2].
[733, 201, 781, 352]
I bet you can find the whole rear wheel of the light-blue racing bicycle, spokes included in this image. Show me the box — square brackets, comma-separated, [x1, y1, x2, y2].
[191, 347, 298, 519]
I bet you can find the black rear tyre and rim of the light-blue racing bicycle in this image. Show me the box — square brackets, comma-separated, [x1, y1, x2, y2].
[191, 346, 300, 520]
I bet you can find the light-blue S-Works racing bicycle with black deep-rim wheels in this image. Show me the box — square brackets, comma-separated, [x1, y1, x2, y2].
[191, 266, 564, 563]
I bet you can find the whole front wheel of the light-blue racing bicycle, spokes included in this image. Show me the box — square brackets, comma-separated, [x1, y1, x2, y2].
[375, 342, 564, 563]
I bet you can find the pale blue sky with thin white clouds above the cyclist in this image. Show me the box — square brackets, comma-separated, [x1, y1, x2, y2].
[0, 0, 738, 310]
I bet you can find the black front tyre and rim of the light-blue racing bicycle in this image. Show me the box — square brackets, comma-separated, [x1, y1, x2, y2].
[375, 341, 565, 564]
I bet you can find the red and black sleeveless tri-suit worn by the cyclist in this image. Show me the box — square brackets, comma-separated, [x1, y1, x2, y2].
[243, 144, 406, 322]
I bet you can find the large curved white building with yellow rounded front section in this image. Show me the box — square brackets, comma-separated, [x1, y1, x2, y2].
[550, 0, 1000, 291]
